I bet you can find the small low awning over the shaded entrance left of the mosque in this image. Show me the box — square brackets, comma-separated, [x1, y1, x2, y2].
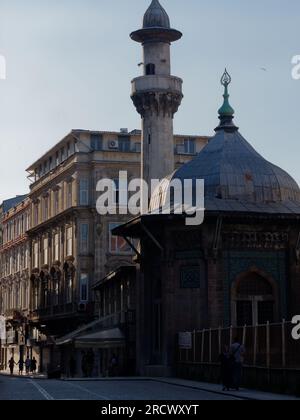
[75, 328, 125, 348]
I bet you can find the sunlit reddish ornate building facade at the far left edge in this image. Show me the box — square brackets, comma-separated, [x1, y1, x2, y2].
[0, 196, 31, 367]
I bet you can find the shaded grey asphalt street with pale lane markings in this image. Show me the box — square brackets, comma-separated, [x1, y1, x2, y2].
[0, 376, 240, 401]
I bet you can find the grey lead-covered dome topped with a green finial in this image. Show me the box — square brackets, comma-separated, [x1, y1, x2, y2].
[150, 74, 300, 213]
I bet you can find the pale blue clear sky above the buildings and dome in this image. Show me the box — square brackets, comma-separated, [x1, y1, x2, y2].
[0, 0, 300, 201]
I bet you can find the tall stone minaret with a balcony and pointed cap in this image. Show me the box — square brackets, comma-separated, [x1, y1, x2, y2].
[130, 0, 183, 205]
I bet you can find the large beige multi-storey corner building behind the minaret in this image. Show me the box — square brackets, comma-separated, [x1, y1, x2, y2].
[22, 129, 208, 370]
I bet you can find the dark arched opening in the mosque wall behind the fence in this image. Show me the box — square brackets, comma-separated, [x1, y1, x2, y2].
[232, 272, 277, 326]
